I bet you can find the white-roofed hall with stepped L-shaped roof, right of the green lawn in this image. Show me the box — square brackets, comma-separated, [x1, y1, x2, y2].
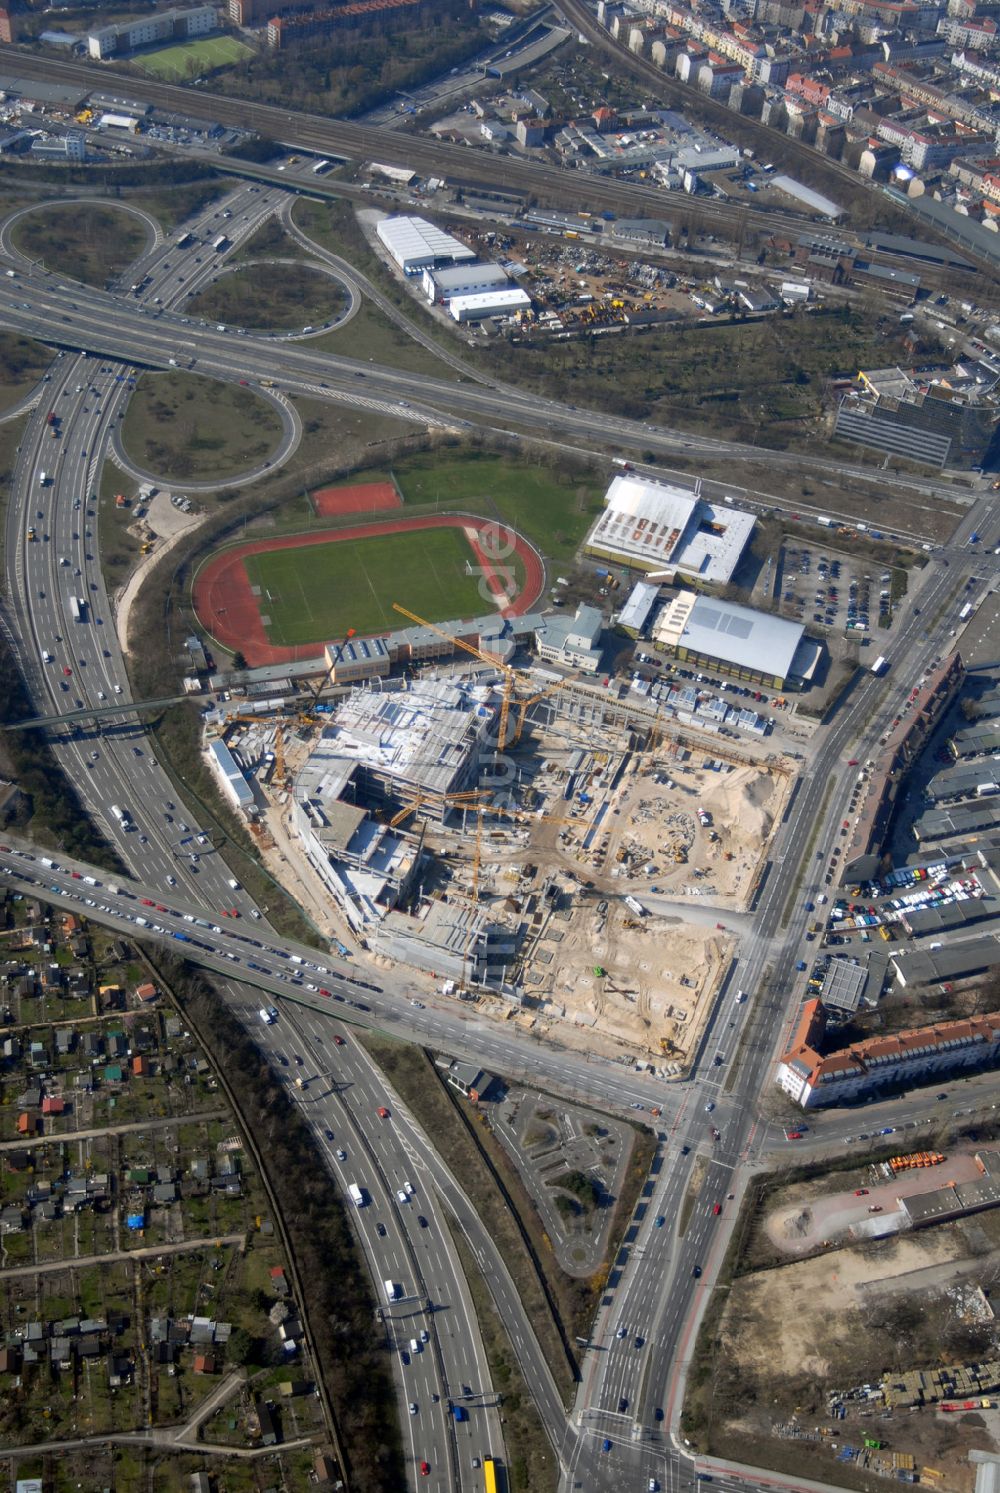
[585, 475, 754, 585]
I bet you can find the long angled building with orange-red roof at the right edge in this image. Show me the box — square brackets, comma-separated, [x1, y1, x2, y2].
[776, 997, 1000, 1109]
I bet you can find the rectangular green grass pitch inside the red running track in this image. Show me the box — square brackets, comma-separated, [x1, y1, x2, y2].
[246, 529, 491, 648]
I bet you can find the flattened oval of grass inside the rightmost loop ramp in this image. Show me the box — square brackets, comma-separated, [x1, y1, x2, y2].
[188, 264, 345, 331]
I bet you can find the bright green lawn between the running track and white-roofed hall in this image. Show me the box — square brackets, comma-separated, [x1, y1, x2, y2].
[391, 451, 604, 560]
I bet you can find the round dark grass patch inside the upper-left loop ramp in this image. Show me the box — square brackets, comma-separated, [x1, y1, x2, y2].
[12, 203, 148, 288]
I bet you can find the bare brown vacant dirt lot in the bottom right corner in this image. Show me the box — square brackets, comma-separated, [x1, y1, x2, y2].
[713, 1200, 1000, 1493]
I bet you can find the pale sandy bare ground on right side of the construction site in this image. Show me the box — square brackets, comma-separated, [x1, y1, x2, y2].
[496, 754, 793, 1076]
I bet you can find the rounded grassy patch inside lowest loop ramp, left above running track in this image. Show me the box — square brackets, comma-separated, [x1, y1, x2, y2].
[122, 372, 281, 482]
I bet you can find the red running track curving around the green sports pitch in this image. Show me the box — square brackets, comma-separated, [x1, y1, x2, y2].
[191, 514, 545, 667]
